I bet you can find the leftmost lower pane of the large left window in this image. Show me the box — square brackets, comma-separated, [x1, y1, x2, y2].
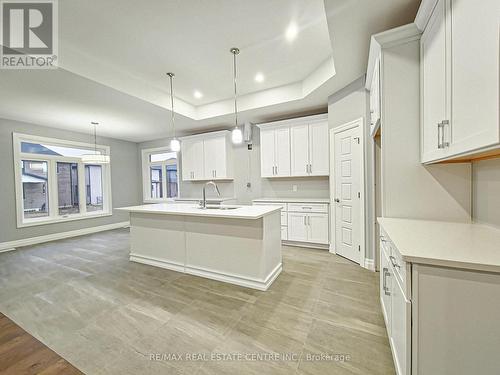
[21, 160, 49, 219]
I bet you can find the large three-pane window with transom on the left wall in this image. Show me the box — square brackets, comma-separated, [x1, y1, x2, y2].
[13, 133, 111, 227]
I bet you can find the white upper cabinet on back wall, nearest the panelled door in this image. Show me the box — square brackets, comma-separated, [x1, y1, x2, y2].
[259, 115, 329, 177]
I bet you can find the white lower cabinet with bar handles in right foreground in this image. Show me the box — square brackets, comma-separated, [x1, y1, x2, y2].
[380, 228, 500, 375]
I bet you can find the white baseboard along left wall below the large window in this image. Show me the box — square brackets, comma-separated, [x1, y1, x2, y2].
[0, 221, 130, 252]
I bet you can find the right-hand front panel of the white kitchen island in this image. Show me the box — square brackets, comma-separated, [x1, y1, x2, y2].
[185, 217, 280, 290]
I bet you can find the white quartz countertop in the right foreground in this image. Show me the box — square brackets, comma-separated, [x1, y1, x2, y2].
[378, 218, 500, 272]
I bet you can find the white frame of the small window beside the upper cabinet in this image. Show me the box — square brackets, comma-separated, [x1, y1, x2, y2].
[141, 146, 181, 203]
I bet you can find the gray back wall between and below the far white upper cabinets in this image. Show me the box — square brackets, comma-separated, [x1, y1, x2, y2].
[139, 126, 329, 204]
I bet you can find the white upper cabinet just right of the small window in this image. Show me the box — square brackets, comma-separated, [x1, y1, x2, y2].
[181, 131, 233, 181]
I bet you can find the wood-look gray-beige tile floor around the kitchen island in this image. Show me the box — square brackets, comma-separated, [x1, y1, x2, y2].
[0, 230, 394, 375]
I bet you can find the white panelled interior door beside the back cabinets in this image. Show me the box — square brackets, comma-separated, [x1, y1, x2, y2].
[333, 119, 364, 264]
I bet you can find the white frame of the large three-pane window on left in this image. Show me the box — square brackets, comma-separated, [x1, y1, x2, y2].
[12, 133, 113, 228]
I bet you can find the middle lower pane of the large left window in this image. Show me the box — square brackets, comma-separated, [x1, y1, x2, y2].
[57, 162, 80, 215]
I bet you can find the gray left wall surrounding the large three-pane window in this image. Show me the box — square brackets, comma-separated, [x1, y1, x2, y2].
[0, 119, 142, 242]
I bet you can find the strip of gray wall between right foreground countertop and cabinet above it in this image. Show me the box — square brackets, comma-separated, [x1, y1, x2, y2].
[472, 159, 500, 228]
